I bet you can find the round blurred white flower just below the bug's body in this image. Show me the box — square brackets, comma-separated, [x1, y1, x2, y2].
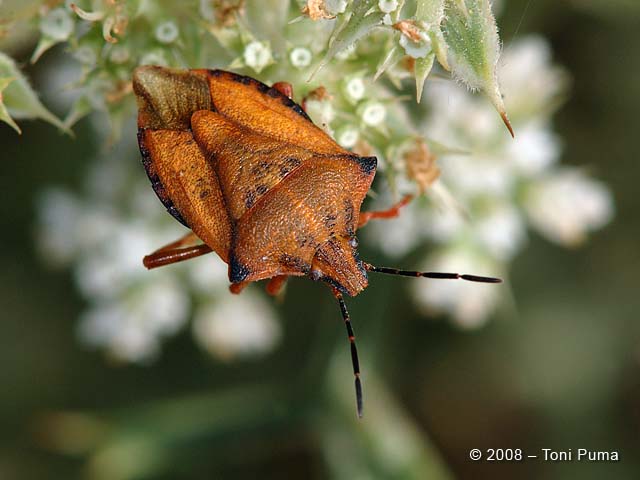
[193, 289, 281, 360]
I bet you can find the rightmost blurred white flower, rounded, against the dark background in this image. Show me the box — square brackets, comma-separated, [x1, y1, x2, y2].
[525, 168, 613, 246]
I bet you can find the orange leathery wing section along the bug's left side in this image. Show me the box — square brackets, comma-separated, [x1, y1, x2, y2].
[141, 129, 231, 262]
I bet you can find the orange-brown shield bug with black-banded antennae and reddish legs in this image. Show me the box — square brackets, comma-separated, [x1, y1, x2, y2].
[133, 66, 500, 416]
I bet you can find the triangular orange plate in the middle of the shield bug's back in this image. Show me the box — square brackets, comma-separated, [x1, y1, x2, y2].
[191, 110, 318, 220]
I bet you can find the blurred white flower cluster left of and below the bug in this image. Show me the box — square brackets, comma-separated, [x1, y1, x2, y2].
[38, 133, 280, 362]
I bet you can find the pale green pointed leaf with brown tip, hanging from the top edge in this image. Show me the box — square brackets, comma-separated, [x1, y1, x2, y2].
[444, 0, 513, 136]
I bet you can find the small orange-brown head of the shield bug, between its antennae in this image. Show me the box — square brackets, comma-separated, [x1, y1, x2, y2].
[309, 236, 369, 297]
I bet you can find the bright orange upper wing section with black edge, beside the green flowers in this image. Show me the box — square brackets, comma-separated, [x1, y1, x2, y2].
[196, 70, 350, 155]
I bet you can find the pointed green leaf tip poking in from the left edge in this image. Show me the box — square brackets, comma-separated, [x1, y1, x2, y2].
[0, 52, 72, 135]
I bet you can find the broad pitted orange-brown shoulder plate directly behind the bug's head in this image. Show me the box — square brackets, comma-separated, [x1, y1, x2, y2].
[230, 156, 375, 282]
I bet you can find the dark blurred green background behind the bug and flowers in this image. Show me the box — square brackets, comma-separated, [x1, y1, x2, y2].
[0, 0, 640, 479]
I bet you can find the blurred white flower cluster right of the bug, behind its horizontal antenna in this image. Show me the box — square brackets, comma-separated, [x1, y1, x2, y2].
[371, 37, 613, 327]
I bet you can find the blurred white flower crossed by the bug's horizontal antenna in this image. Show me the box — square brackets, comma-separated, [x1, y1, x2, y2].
[411, 248, 504, 328]
